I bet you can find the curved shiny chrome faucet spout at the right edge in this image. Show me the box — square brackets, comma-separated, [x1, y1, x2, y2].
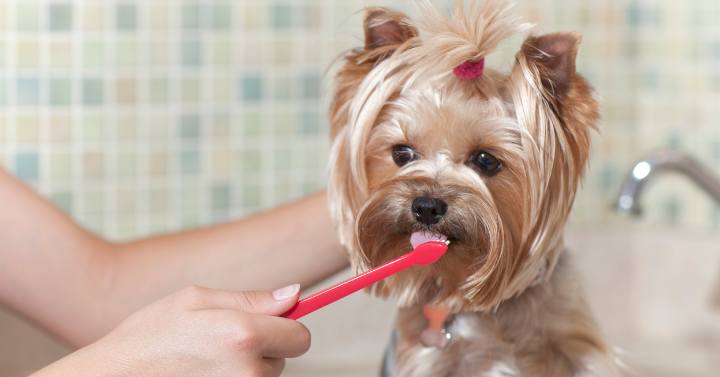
[615, 150, 720, 216]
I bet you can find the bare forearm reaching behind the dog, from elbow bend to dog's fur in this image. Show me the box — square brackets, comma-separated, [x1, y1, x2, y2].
[110, 193, 348, 330]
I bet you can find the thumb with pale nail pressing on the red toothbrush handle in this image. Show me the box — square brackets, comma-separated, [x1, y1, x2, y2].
[208, 284, 300, 315]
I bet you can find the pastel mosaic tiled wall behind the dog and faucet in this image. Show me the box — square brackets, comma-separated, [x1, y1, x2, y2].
[0, 0, 720, 239]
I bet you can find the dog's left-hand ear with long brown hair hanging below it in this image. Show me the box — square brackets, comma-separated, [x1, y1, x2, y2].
[330, 8, 418, 138]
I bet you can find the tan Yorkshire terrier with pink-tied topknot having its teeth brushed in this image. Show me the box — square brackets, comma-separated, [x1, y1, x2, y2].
[329, 0, 621, 377]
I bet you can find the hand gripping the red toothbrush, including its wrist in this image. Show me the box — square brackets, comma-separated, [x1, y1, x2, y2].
[36, 285, 310, 377]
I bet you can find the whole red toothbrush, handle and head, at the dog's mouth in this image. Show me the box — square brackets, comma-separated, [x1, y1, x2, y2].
[282, 241, 450, 319]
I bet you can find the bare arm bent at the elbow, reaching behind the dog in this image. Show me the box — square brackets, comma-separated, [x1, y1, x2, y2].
[0, 170, 347, 345]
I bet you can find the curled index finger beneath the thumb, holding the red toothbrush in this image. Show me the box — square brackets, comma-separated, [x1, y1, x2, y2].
[237, 314, 310, 358]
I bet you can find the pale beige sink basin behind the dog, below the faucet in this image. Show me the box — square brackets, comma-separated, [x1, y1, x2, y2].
[284, 223, 720, 377]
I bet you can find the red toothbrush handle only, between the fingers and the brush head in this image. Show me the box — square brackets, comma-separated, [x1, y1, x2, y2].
[282, 252, 416, 319]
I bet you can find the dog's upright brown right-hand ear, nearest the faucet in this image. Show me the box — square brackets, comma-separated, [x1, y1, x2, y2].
[520, 32, 582, 101]
